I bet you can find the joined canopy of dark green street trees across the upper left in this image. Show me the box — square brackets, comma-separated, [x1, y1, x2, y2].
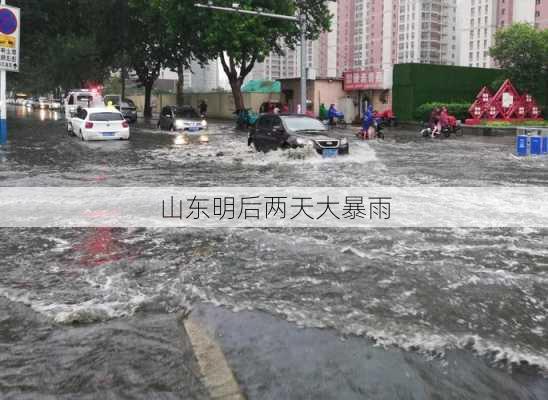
[9, 0, 332, 114]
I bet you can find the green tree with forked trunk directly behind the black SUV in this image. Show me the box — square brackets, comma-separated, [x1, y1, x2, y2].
[200, 0, 332, 110]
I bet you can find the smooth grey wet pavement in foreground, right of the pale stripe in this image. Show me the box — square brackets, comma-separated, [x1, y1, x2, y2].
[191, 305, 548, 400]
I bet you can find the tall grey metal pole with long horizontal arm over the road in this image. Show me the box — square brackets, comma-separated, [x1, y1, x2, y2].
[194, 1, 307, 114]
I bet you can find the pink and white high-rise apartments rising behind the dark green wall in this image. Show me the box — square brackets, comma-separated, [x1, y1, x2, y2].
[338, 0, 459, 89]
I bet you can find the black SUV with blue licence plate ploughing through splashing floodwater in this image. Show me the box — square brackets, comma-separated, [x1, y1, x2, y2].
[248, 114, 349, 157]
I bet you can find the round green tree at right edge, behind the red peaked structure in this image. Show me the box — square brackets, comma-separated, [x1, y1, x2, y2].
[490, 23, 548, 108]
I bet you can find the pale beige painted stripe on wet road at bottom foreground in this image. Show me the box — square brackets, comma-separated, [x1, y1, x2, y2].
[184, 319, 245, 400]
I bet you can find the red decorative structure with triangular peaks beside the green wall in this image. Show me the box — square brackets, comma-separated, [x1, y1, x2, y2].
[466, 79, 541, 125]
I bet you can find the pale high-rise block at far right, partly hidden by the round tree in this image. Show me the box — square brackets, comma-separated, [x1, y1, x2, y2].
[459, 0, 536, 68]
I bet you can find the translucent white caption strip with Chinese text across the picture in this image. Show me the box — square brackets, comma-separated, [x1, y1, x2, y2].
[0, 187, 548, 228]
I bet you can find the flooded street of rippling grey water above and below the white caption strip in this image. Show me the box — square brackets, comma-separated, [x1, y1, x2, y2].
[0, 108, 548, 399]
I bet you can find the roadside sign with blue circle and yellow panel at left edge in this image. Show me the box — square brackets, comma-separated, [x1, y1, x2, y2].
[0, 5, 21, 72]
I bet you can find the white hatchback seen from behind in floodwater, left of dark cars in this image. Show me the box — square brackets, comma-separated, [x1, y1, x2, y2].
[67, 108, 129, 141]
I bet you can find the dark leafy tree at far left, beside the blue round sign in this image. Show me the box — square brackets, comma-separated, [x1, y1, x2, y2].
[9, 0, 122, 93]
